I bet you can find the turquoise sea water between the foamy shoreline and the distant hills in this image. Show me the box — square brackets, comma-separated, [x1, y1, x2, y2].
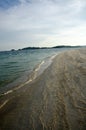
[0, 49, 70, 91]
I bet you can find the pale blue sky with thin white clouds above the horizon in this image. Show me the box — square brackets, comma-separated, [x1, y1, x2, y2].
[0, 0, 86, 50]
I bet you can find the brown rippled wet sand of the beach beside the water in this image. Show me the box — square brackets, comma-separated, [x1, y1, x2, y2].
[0, 49, 86, 130]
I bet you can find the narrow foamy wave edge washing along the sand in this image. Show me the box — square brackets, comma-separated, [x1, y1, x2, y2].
[0, 54, 57, 96]
